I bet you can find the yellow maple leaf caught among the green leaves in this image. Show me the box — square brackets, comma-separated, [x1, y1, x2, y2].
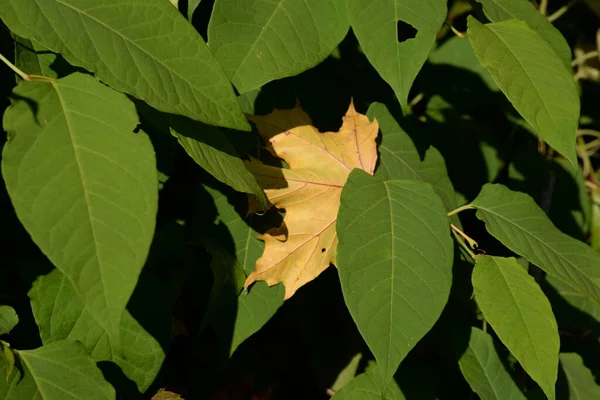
[245, 103, 379, 299]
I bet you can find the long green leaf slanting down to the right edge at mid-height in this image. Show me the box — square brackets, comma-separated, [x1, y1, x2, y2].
[471, 184, 600, 303]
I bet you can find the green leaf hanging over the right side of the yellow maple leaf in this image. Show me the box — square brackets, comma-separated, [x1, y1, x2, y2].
[336, 170, 453, 384]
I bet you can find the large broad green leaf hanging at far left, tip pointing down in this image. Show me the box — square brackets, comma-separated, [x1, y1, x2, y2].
[2, 73, 158, 348]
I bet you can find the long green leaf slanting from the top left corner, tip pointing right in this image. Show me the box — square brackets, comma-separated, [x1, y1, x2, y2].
[0, 0, 250, 130]
